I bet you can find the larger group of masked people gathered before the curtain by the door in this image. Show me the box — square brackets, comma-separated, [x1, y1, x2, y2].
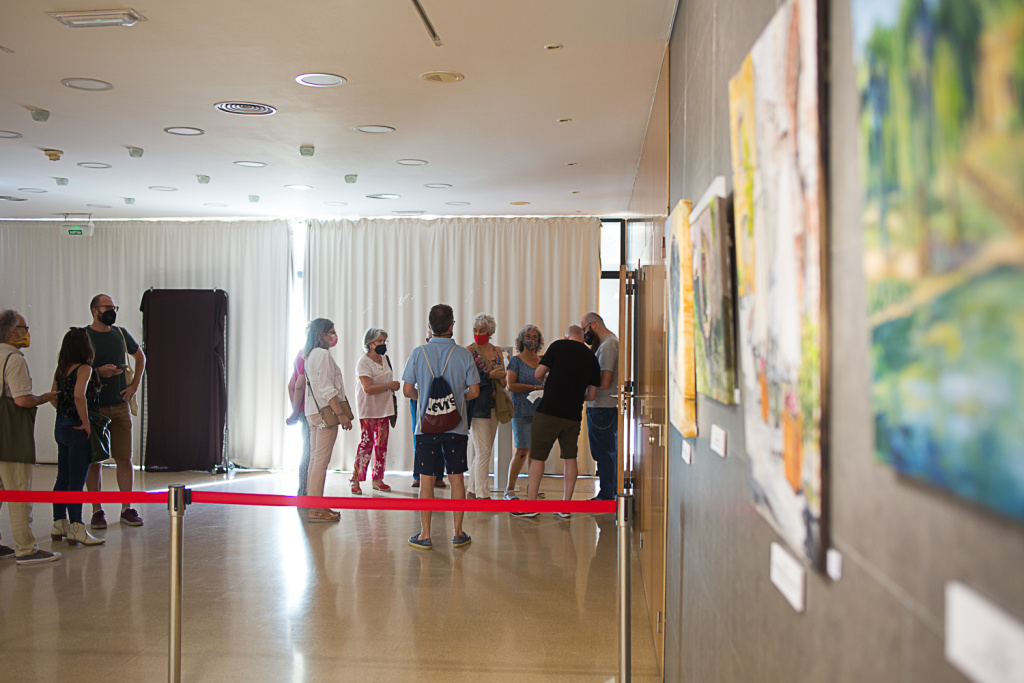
[280, 304, 618, 550]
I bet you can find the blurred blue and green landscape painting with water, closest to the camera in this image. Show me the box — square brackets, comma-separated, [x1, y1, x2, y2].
[852, 0, 1024, 520]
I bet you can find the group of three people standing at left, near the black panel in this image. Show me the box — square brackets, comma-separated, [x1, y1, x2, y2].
[0, 294, 145, 565]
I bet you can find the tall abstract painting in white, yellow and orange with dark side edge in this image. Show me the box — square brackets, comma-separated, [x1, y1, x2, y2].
[729, 0, 826, 567]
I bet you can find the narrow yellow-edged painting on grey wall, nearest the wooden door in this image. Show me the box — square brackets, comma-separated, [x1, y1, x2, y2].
[668, 200, 697, 438]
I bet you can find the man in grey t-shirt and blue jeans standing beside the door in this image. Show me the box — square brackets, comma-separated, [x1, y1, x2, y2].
[580, 311, 618, 501]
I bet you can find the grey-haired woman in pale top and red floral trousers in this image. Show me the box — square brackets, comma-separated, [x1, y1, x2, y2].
[351, 328, 401, 496]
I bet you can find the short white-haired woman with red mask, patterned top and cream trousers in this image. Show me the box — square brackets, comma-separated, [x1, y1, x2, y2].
[466, 313, 505, 498]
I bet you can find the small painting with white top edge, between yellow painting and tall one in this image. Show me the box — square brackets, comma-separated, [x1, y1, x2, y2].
[690, 178, 736, 405]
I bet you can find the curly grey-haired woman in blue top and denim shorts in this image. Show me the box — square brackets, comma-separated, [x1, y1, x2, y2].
[504, 325, 544, 501]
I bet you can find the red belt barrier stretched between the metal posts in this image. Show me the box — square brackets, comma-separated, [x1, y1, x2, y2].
[0, 488, 615, 514]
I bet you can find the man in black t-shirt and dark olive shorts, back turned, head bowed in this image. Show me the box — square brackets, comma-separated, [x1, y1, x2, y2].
[512, 325, 601, 519]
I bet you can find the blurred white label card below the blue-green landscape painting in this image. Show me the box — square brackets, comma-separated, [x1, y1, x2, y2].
[946, 581, 1024, 683]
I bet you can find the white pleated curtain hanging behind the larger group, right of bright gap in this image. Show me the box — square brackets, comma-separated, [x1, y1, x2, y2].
[303, 218, 601, 471]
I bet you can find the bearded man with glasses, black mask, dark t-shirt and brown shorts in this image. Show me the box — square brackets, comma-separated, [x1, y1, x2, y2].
[85, 294, 145, 528]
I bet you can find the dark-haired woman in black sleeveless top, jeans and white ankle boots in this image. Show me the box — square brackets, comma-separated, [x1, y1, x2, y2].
[50, 328, 104, 546]
